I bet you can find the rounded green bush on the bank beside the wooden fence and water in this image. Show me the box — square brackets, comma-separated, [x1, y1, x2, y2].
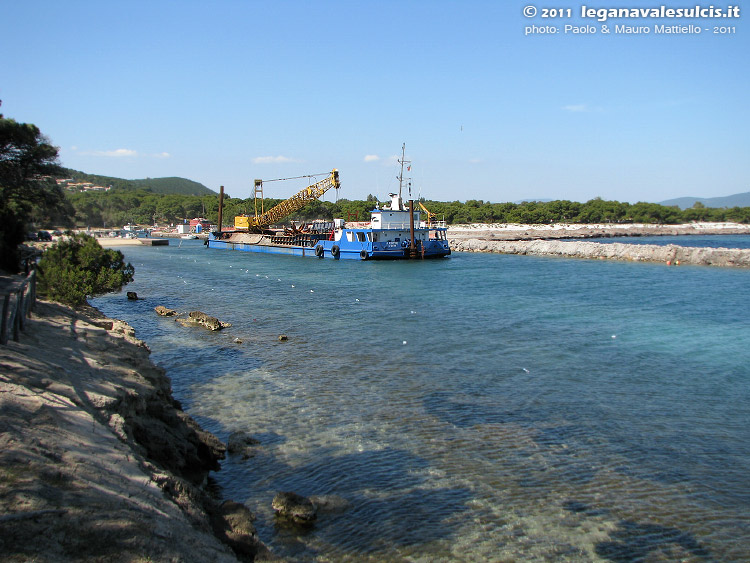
[38, 234, 135, 306]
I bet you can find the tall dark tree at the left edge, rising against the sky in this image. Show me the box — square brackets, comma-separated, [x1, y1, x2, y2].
[0, 114, 71, 271]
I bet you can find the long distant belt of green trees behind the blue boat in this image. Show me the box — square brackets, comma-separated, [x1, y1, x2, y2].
[68, 190, 750, 227]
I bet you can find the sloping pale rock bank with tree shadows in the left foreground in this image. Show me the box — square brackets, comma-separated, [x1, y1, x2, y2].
[0, 301, 274, 562]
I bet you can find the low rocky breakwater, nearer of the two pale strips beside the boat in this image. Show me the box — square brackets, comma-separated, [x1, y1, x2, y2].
[451, 239, 750, 268]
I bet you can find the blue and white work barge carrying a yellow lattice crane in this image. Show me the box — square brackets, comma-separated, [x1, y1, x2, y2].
[206, 147, 451, 260]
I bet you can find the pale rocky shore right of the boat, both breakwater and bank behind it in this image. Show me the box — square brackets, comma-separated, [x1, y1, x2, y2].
[448, 223, 750, 268]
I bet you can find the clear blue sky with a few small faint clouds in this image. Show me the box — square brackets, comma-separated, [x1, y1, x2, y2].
[0, 0, 750, 202]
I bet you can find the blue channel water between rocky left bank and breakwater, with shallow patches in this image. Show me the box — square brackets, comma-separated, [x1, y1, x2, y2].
[92, 241, 750, 561]
